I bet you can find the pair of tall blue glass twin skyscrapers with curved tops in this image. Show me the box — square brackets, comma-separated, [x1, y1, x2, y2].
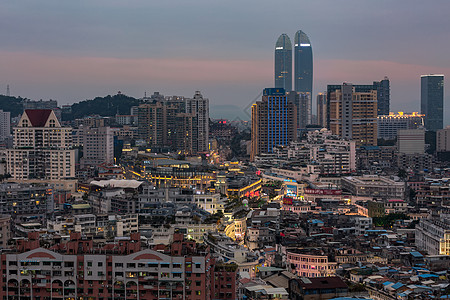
[275, 30, 313, 127]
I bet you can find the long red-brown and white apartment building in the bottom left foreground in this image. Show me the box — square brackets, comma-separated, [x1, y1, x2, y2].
[0, 233, 237, 300]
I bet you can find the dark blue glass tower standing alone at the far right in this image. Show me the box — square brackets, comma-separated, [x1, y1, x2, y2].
[420, 74, 444, 131]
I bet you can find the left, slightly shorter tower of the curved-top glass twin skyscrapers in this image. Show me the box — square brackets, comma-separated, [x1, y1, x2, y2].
[275, 33, 292, 91]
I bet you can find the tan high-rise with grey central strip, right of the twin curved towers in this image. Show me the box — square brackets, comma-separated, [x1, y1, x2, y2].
[329, 83, 377, 146]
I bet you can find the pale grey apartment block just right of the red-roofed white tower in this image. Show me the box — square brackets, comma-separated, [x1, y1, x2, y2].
[80, 127, 114, 168]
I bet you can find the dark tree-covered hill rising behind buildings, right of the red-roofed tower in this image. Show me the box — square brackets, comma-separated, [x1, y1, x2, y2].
[62, 94, 139, 121]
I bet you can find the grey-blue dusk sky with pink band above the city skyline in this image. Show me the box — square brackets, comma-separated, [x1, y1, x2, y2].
[0, 0, 450, 124]
